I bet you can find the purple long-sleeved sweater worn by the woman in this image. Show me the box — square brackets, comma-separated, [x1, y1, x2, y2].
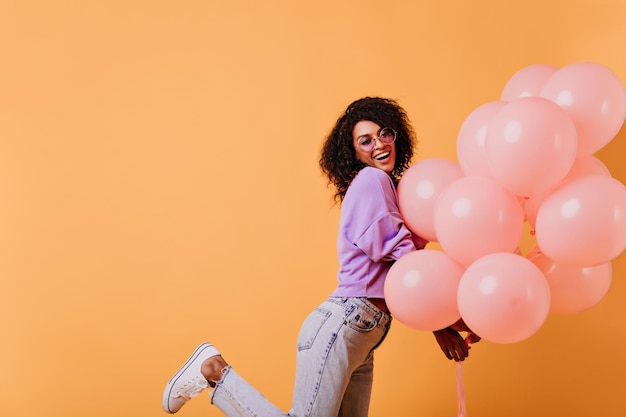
[331, 167, 426, 298]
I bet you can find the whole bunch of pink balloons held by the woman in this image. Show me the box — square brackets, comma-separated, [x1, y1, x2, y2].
[385, 62, 626, 343]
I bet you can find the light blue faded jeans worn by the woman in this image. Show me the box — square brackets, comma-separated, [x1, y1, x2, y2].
[211, 298, 391, 417]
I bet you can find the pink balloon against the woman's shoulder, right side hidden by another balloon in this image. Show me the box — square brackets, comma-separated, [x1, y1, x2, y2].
[398, 158, 463, 242]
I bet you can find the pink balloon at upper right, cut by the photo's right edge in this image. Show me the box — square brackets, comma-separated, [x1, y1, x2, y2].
[541, 62, 626, 155]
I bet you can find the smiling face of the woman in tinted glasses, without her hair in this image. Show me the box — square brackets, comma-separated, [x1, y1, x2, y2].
[352, 120, 396, 174]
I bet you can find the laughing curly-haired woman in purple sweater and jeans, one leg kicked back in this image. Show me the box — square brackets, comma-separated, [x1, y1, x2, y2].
[163, 97, 478, 417]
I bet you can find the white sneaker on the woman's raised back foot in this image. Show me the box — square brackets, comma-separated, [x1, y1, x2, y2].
[163, 343, 220, 414]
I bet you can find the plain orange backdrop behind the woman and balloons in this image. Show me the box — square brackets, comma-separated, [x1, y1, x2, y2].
[0, 0, 626, 417]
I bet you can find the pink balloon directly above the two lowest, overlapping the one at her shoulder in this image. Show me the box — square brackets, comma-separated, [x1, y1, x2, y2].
[434, 176, 524, 265]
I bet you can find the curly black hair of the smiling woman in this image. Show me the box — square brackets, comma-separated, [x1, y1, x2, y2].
[320, 97, 417, 202]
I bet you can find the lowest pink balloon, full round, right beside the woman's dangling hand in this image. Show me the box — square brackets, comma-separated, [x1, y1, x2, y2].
[457, 253, 550, 343]
